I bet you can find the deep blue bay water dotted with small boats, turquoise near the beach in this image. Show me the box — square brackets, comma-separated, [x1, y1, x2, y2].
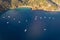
[0, 8, 60, 40]
